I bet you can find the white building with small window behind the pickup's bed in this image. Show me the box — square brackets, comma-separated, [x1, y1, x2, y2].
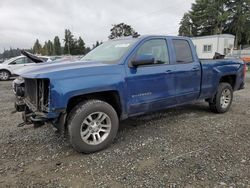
[192, 34, 235, 59]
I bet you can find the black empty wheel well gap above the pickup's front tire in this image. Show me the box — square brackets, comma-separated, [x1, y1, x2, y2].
[67, 91, 122, 117]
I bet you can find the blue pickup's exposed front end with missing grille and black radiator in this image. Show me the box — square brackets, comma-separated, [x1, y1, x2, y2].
[13, 77, 51, 125]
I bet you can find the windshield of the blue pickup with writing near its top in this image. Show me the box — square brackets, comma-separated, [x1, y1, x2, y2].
[81, 39, 137, 63]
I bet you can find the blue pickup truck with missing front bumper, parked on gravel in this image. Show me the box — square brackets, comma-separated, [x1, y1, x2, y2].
[15, 36, 246, 153]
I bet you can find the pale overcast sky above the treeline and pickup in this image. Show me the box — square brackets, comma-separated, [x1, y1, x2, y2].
[0, 0, 194, 52]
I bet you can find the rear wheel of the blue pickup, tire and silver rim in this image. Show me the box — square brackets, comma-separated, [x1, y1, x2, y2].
[209, 82, 233, 113]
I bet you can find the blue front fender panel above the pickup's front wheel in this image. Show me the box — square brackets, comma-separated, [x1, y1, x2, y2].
[50, 69, 127, 112]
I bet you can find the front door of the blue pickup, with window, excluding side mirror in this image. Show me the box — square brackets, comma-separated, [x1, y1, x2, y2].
[126, 38, 176, 115]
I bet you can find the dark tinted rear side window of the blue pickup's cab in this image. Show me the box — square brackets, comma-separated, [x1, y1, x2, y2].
[173, 39, 194, 63]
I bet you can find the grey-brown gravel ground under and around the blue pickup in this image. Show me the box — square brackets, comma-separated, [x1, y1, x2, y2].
[0, 81, 250, 187]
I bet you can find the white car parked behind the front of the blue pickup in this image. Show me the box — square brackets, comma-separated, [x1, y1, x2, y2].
[0, 55, 52, 80]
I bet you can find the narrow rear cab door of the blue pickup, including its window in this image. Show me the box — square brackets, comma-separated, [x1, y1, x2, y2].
[172, 39, 201, 104]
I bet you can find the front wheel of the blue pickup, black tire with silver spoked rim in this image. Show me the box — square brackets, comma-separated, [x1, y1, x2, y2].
[68, 100, 119, 153]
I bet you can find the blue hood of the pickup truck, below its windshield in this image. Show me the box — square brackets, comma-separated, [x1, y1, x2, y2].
[14, 61, 114, 79]
